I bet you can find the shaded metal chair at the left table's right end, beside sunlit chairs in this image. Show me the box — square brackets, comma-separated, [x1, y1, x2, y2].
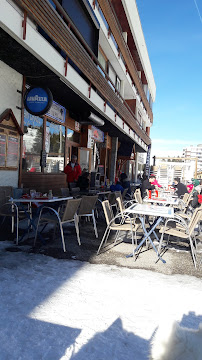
[78, 195, 98, 238]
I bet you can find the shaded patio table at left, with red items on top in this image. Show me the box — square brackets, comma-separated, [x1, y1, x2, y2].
[9, 196, 73, 241]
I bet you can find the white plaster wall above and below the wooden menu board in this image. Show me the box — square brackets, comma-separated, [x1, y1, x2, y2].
[0, 61, 23, 187]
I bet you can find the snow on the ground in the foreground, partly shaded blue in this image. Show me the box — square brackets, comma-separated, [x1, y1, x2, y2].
[0, 242, 202, 360]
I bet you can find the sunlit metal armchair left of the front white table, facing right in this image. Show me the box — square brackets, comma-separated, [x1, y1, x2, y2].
[97, 200, 139, 256]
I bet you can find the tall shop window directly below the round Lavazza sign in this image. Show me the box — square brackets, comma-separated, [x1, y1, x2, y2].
[22, 110, 43, 172]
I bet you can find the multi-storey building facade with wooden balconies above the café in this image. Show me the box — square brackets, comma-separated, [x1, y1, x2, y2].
[0, 0, 156, 190]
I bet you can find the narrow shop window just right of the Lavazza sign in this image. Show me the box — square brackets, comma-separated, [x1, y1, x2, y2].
[44, 121, 65, 173]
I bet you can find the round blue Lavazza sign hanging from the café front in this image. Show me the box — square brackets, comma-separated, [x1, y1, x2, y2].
[24, 87, 53, 116]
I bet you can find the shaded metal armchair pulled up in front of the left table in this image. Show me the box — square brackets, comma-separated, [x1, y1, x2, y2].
[34, 199, 81, 252]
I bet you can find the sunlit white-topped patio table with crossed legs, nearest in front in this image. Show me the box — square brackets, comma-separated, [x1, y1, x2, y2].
[124, 204, 174, 263]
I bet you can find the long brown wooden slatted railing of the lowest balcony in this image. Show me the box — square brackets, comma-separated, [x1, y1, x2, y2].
[15, 0, 151, 145]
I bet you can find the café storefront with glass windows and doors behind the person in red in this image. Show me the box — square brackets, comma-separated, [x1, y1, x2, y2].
[20, 93, 111, 192]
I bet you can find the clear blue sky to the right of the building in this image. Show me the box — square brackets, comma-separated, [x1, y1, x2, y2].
[136, 0, 202, 156]
